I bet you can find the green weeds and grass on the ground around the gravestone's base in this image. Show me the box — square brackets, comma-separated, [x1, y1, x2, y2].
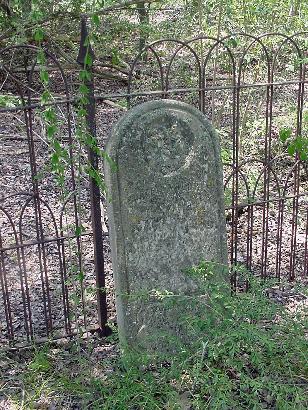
[0, 262, 308, 410]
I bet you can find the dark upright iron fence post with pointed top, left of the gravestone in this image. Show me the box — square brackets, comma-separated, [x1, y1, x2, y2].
[77, 16, 110, 336]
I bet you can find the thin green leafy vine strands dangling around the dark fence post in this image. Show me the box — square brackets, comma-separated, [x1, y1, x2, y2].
[33, 15, 114, 340]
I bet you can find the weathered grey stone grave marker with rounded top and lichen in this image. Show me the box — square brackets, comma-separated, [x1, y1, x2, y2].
[105, 100, 227, 351]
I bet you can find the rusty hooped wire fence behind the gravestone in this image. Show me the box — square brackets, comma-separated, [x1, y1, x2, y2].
[0, 22, 308, 345]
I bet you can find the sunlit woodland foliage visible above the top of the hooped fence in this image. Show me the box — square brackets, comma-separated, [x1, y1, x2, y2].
[0, 0, 308, 58]
